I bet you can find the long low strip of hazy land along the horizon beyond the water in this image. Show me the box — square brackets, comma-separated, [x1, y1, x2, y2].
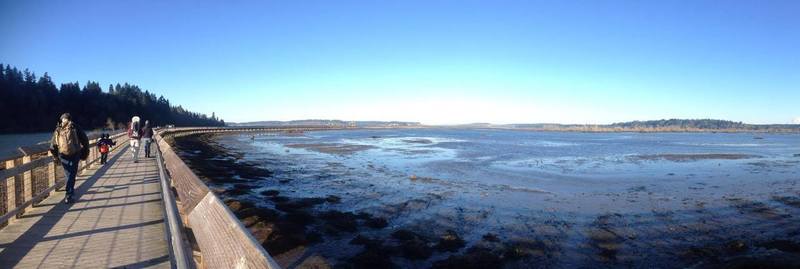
[228, 119, 800, 133]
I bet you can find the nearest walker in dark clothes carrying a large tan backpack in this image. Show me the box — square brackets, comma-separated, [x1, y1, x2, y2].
[50, 113, 89, 204]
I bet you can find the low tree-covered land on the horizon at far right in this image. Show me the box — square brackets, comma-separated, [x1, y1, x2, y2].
[506, 119, 800, 132]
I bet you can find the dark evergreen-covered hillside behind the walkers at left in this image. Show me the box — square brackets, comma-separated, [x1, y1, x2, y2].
[0, 64, 225, 133]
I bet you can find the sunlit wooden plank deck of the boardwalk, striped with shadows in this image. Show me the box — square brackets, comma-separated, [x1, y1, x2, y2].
[0, 147, 170, 268]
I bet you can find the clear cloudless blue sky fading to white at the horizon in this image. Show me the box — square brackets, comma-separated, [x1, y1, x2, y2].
[0, 0, 800, 124]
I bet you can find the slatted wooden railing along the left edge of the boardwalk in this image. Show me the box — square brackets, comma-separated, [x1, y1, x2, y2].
[0, 133, 125, 227]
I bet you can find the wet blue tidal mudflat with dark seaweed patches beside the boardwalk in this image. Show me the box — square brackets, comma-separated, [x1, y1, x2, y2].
[176, 129, 800, 268]
